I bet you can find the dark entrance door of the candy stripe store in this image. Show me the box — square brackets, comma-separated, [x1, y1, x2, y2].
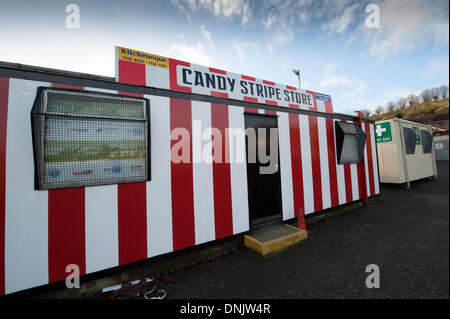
[245, 114, 281, 226]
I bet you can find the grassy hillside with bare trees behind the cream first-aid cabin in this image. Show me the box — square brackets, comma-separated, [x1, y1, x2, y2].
[370, 97, 448, 121]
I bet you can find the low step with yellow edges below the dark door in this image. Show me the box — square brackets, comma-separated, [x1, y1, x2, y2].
[244, 224, 308, 256]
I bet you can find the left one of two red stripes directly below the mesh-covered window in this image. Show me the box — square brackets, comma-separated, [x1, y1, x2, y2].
[48, 187, 86, 282]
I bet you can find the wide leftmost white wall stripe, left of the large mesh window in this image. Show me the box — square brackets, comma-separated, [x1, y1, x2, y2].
[5, 79, 50, 293]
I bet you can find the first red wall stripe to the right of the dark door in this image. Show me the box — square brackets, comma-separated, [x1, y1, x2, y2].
[289, 113, 305, 218]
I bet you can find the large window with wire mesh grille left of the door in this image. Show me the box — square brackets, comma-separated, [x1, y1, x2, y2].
[31, 87, 150, 189]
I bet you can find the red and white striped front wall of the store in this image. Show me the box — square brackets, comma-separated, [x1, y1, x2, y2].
[0, 74, 379, 295]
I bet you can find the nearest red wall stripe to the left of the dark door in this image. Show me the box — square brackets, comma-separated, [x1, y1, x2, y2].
[211, 103, 233, 239]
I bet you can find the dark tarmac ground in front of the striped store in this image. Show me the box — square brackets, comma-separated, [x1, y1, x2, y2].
[149, 161, 449, 299]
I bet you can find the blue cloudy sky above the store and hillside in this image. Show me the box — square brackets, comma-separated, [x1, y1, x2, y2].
[0, 0, 449, 113]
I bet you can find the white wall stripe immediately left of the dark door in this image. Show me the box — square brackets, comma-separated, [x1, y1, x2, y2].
[228, 105, 249, 234]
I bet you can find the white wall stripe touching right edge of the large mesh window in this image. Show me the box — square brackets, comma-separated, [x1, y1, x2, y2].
[145, 96, 173, 257]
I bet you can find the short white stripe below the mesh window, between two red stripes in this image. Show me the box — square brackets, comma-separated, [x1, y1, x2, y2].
[85, 185, 119, 273]
